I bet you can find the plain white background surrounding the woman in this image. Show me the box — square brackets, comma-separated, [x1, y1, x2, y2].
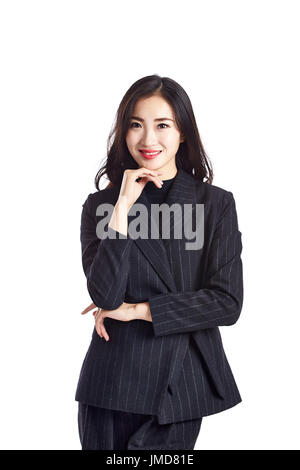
[0, 0, 300, 449]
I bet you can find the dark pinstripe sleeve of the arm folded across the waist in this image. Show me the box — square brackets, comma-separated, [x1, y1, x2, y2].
[149, 191, 243, 336]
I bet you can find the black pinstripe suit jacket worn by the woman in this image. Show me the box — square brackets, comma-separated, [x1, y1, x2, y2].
[75, 168, 243, 424]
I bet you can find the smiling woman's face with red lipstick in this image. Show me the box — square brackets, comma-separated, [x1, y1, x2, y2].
[126, 95, 183, 179]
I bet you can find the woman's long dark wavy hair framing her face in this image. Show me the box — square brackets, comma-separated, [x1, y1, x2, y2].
[95, 75, 213, 190]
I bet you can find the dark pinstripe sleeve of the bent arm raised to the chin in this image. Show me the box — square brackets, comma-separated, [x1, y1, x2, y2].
[80, 194, 133, 310]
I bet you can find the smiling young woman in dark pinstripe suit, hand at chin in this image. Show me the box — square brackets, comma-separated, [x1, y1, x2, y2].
[75, 75, 243, 450]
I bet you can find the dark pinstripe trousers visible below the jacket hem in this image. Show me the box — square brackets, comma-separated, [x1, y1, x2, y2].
[78, 402, 202, 450]
